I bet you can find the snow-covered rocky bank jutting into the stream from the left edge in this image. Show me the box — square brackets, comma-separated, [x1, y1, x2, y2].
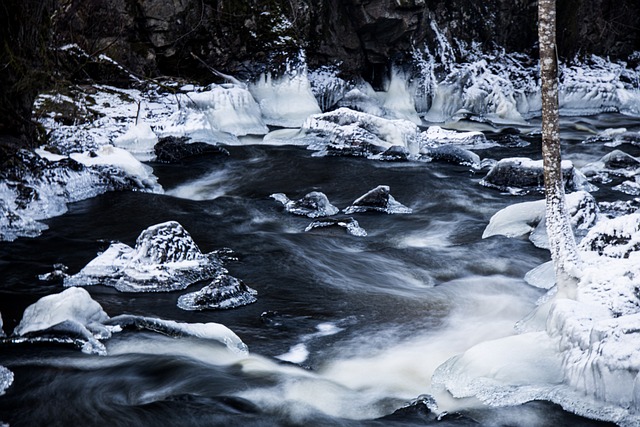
[0, 150, 162, 241]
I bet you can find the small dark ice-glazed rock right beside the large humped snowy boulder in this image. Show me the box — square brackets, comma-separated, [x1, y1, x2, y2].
[178, 274, 257, 311]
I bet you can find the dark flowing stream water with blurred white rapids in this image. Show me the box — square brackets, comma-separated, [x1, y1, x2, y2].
[0, 115, 640, 426]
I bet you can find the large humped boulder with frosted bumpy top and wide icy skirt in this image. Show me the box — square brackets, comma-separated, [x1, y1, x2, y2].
[64, 221, 226, 292]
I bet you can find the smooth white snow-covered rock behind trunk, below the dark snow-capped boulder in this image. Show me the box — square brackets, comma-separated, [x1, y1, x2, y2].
[482, 191, 600, 248]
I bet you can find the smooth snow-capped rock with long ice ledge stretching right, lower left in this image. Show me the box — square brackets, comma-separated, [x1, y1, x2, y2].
[6, 288, 248, 356]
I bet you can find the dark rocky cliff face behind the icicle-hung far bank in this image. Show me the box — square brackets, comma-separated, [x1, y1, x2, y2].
[48, 0, 640, 81]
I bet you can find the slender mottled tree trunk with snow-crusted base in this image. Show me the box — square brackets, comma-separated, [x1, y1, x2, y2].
[538, 0, 578, 297]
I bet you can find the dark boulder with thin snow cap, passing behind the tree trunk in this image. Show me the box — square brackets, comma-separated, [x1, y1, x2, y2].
[480, 157, 596, 194]
